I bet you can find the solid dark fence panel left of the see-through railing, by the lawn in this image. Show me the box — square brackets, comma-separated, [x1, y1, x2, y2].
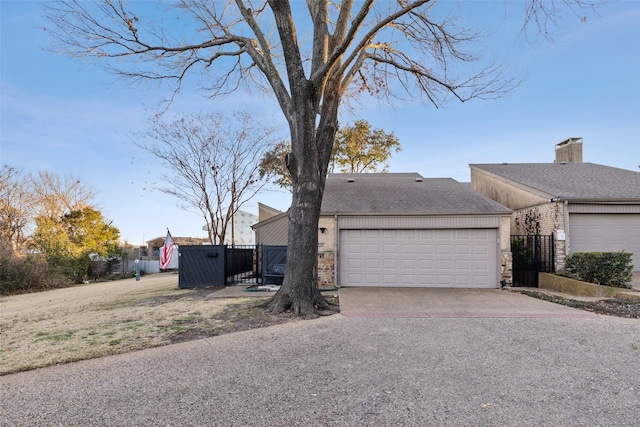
[178, 245, 226, 288]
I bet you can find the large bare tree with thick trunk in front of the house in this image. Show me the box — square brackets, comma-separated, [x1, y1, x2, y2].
[49, 0, 600, 315]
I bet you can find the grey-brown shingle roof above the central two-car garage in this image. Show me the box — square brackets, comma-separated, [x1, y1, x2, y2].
[322, 173, 511, 215]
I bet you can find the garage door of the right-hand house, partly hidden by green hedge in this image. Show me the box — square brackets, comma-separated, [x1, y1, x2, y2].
[569, 213, 640, 271]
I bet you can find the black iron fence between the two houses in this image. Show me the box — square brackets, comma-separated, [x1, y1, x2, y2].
[511, 234, 555, 288]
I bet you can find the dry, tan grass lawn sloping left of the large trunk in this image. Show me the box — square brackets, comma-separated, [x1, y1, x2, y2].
[0, 274, 294, 375]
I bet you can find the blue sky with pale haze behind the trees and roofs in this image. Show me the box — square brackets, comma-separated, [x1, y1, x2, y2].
[0, 0, 640, 244]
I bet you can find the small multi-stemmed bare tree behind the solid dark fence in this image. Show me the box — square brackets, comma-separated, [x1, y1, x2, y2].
[136, 113, 276, 245]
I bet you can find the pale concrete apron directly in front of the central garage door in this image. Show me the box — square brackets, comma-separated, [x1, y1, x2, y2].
[339, 288, 597, 318]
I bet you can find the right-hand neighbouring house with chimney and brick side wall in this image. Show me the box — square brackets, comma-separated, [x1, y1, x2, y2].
[470, 138, 640, 272]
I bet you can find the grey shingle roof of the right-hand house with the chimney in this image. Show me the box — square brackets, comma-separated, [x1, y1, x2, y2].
[470, 163, 640, 201]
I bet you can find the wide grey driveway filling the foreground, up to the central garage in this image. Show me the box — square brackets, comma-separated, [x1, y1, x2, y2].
[0, 289, 640, 426]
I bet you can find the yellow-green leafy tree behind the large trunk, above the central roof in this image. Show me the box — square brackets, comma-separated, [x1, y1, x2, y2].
[260, 120, 401, 190]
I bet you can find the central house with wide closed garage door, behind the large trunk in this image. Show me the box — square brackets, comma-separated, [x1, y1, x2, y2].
[254, 173, 511, 288]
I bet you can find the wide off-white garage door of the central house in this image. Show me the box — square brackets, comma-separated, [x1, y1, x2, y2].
[338, 229, 499, 288]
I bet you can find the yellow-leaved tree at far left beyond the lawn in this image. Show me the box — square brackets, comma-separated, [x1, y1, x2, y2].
[33, 206, 120, 281]
